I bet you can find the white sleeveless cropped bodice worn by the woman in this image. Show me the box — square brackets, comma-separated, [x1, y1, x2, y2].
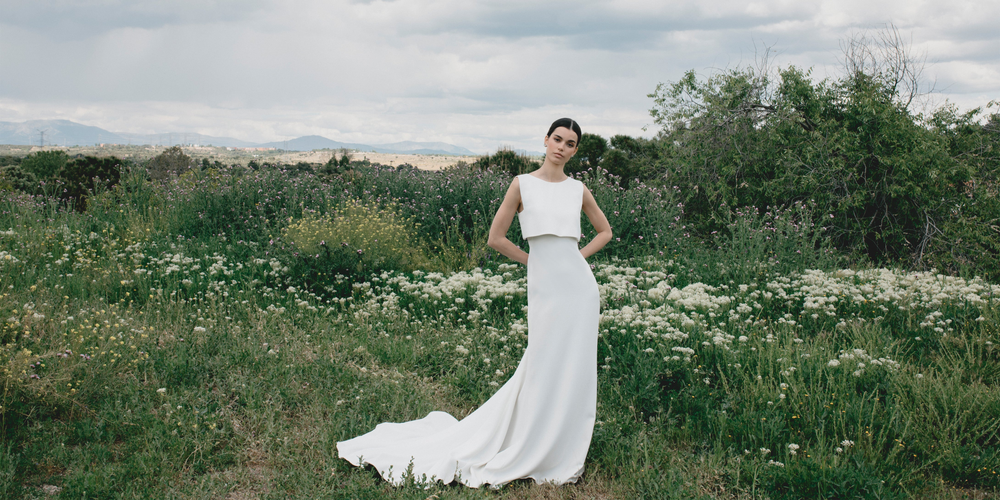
[517, 174, 583, 241]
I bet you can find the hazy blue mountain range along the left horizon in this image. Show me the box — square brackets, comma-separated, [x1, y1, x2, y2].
[0, 120, 478, 156]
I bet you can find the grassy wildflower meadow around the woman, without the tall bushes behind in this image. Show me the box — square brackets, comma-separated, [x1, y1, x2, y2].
[0, 164, 1000, 499]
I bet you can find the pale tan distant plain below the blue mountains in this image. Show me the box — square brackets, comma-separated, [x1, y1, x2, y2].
[0, 145, 478, 170]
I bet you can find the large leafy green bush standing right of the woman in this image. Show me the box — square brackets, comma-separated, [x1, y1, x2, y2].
[651, 67, 973, 268]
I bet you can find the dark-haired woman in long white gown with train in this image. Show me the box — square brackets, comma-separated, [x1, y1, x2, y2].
[337, 118, 611, 488]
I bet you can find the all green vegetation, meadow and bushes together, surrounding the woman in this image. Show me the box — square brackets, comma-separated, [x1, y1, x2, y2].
[0, 28, 1000, 500]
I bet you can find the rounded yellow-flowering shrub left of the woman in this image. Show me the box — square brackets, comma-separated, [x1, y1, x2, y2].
[284, 198, 426, 294]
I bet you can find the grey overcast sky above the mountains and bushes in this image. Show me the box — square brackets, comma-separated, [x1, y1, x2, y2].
[0, 0, 1000, 152]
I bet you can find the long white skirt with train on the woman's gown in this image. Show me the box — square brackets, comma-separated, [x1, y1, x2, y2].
[337, 235, 600, 488]
